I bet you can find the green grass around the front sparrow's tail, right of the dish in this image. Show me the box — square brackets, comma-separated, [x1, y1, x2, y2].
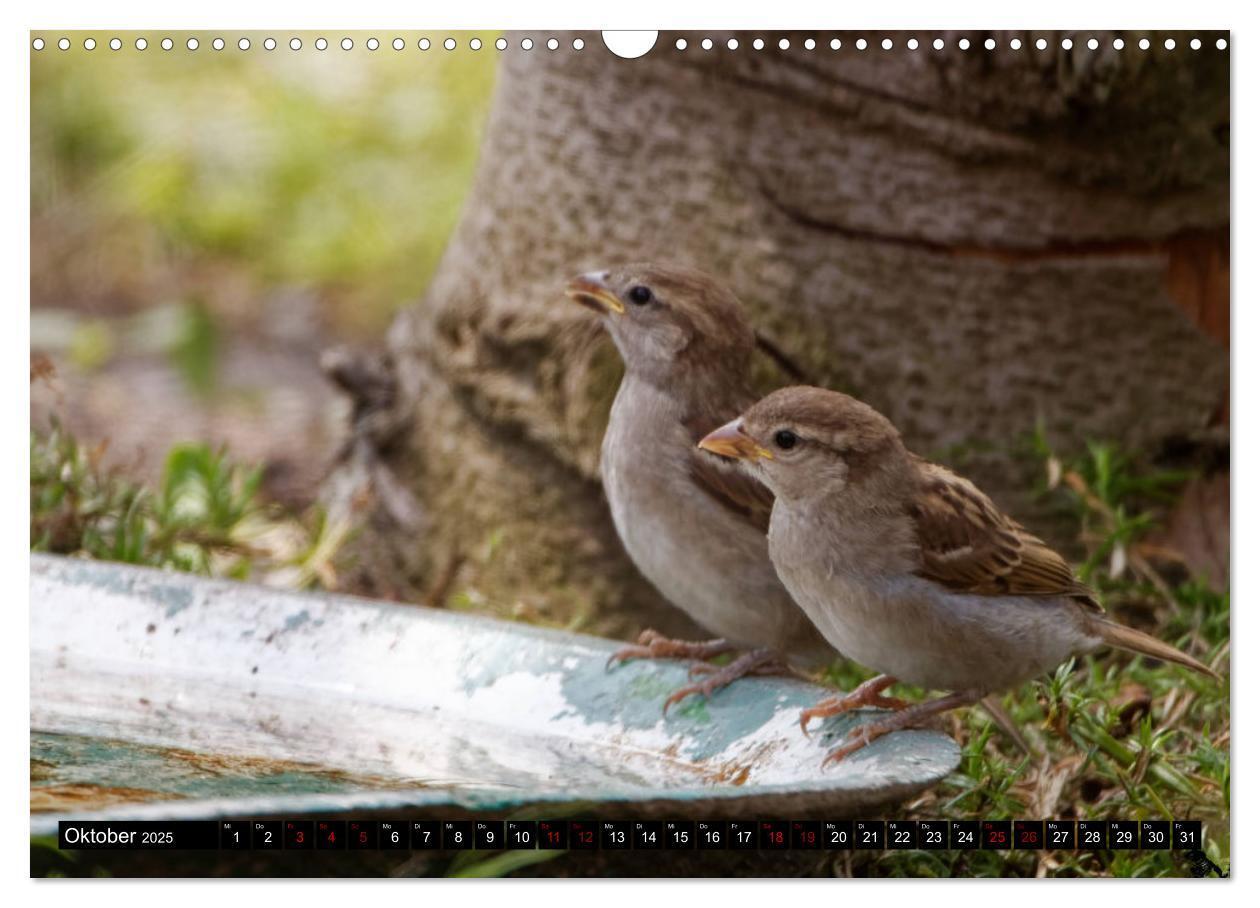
[827, 437, 1230, 877]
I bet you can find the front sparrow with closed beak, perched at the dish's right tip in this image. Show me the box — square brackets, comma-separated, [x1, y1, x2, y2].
[699, 387, 1220, 764]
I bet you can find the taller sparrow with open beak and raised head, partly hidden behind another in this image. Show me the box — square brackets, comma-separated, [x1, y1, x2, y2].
[566, 264, 835, 712]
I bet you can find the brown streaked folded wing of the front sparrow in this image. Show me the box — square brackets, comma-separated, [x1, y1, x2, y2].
[910, 460, 1101, 611]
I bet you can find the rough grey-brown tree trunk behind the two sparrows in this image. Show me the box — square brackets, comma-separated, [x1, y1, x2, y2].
[330, 33, 1230, 635]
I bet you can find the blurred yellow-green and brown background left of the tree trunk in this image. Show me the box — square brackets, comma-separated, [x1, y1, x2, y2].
[30, 31, 500, 502]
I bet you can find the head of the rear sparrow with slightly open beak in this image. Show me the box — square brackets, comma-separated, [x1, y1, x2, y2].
[564, 264, 755, 379]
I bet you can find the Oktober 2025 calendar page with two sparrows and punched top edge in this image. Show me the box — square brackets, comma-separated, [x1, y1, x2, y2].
[29, 24, 1232, 880]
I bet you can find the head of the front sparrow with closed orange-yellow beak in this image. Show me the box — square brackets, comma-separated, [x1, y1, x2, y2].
[699, 387, 908, 501]
